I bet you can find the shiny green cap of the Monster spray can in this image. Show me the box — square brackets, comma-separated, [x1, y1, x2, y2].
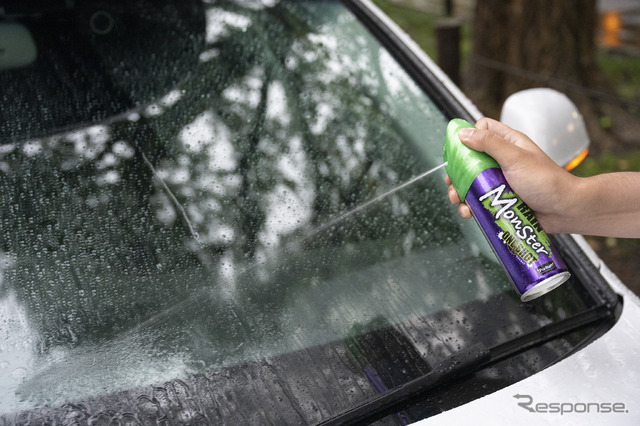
[443, 118, 500, 201]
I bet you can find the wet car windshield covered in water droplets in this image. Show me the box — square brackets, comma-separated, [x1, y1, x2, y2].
[0, 0, 608, 424]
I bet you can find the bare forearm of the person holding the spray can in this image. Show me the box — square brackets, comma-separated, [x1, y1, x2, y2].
[555, 172, 640, 238]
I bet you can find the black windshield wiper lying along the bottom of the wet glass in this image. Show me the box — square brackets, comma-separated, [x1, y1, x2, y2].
[319, 304, 614, 426]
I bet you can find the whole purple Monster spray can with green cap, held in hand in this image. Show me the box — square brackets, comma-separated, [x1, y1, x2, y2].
[444, 119, 571, 302]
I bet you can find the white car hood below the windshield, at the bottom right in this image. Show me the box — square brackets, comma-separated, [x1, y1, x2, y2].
[415, 235, 640, 426]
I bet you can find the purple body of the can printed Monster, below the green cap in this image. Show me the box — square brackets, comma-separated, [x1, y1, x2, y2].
[465, 169, 570, 302]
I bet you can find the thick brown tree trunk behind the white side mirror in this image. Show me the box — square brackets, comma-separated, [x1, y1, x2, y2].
[464, 0, 636, 151]
